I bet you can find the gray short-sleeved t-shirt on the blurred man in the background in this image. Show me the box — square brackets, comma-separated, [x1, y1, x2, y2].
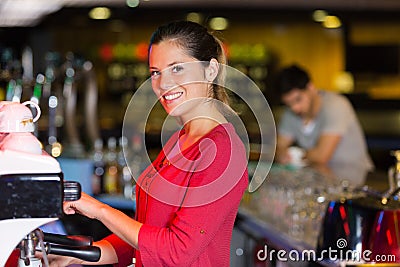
[278, 91, 373, 173]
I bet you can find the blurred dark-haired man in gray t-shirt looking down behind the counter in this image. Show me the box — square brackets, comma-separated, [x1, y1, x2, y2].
[275, 65, 374, 174]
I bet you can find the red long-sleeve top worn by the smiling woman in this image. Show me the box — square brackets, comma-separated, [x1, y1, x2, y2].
[107, 123, 248, 267]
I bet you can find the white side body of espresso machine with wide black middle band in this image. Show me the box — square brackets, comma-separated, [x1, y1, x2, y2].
[0, 147, 64, 266]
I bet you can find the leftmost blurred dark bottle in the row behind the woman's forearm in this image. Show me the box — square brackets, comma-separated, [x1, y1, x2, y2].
[92, 138, 105, 195]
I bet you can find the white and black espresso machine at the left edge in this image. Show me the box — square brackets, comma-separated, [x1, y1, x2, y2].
[0, 101, 100, 267]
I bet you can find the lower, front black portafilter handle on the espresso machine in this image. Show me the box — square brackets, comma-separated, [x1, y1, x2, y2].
[46, 244, 101, 262]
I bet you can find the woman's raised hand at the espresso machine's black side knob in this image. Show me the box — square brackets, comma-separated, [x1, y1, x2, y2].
[64, 193, 107, 219]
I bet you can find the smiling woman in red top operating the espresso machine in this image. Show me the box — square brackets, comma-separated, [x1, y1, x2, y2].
[49, 21, 248, 266]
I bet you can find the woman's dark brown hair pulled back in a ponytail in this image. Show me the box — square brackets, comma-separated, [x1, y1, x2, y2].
[149, 21, 229, 104]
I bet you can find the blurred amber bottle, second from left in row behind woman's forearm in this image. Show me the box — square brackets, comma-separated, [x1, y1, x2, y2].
[104, 137, 120, 194]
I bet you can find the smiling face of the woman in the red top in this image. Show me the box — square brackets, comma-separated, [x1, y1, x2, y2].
[149, 41, 210, 116]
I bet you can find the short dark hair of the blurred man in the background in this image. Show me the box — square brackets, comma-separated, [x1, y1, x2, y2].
[276, 64, 310, 96]
